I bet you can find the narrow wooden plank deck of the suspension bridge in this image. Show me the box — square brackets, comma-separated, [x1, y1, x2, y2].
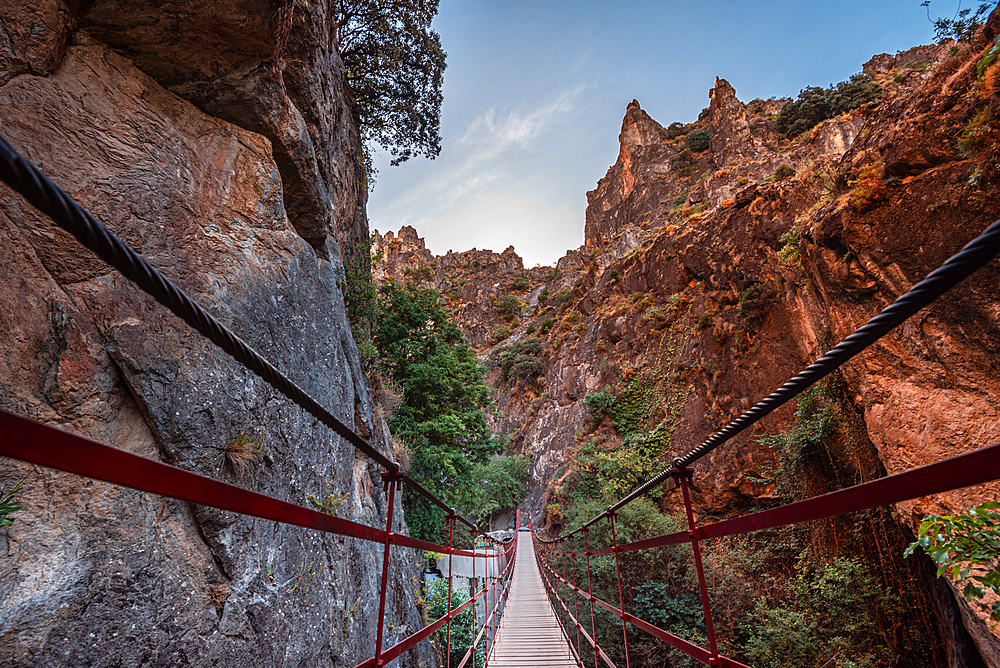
[489, 530, 577, 668]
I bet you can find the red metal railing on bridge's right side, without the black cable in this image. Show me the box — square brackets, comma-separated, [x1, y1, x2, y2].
[532, 444, 1000, 668]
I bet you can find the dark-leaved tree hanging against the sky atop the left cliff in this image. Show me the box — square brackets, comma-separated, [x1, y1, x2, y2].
[335, 0, 447, 165]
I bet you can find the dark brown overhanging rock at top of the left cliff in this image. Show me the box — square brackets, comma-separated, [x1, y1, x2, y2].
[77, 0, 367, 255]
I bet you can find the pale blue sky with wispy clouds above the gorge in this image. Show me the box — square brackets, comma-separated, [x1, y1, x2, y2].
[368, 0, 944, 266]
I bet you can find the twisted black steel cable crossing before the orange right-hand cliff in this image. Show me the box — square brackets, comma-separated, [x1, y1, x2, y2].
[554, 221, 1000, 540]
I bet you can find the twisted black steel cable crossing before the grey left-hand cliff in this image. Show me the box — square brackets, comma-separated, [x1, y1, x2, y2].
[0, 136, 478, 530]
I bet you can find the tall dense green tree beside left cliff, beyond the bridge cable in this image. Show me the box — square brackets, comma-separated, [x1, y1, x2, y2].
[374, 281, 499, 541]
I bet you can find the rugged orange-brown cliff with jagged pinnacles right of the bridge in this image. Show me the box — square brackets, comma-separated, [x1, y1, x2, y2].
[375, 36, 1000, 666]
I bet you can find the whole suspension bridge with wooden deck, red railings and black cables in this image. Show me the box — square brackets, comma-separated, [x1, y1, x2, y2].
[0, 132, 1000, 668]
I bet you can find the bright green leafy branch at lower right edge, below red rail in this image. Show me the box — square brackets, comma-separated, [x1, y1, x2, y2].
[905, 501, 1000, 622]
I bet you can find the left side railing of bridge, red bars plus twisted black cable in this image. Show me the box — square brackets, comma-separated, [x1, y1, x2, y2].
[0, 137, 516, 666]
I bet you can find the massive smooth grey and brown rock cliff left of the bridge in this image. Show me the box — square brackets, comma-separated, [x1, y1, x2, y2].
[0, 0, 433, 666]
